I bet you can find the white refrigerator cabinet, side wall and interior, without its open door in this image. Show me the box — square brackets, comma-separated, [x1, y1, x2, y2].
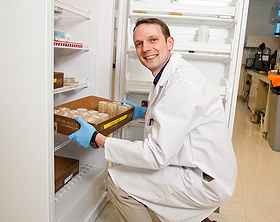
[0, 0, 115, 222]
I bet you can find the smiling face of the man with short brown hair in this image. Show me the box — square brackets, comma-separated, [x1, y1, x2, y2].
[133, 23, 174, 77]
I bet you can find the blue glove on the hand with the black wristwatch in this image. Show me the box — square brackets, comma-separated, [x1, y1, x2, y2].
[68, 117, 96, 148]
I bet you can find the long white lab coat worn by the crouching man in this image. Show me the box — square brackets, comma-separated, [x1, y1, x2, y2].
[105, 53, 237, 222]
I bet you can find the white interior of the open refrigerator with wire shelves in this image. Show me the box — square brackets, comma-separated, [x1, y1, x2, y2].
[52, 0, 115, 222]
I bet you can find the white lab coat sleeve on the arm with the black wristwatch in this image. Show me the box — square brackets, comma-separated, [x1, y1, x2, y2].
[105, 75, 205, 170]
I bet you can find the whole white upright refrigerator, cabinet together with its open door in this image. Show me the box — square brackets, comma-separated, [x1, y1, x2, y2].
[0, 0, 248, 222]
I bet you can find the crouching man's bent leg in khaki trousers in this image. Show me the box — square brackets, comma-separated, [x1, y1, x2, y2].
[106, 174, 152, 222]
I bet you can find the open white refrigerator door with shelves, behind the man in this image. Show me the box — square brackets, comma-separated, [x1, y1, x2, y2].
[115, 0, 249, 139]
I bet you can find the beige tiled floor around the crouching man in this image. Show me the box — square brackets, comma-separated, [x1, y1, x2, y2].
[95, 102, 280, 222]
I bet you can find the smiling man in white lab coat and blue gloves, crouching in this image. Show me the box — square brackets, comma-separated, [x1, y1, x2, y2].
[69, 19, 237, 222]
